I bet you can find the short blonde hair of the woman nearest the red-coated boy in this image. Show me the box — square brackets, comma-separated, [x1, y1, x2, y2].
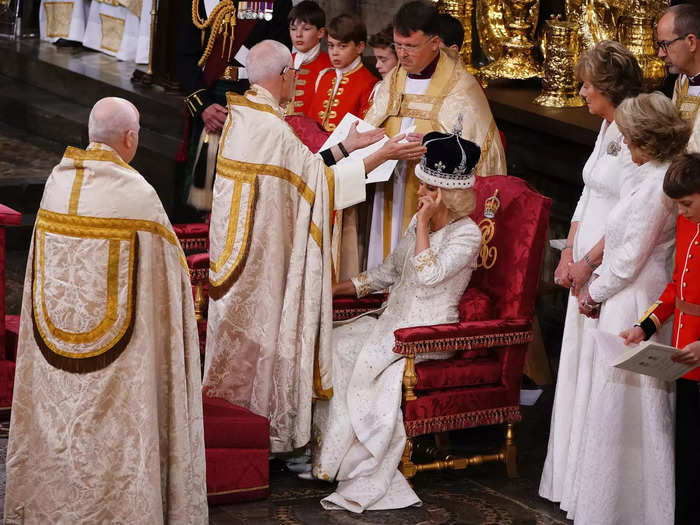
[615, 91, 690, 161]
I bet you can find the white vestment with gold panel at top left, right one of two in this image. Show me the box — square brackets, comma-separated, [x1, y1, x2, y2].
[83, 0, 154, 64]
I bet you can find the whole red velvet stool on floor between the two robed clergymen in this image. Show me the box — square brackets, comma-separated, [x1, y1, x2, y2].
[202, 396, 270, 504]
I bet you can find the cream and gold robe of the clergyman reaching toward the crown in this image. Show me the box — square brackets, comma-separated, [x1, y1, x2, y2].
[204, 85, 365, 452]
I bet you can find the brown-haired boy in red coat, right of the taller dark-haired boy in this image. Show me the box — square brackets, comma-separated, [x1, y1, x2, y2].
[311, 15, 377, 131]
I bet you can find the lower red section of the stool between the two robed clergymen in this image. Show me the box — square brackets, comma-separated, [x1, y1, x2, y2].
[205, 448, 270, 504]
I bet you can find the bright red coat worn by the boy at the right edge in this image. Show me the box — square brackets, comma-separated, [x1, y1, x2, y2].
[639, 215, 700, 381]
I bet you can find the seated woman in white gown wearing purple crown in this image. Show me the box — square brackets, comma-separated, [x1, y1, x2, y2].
[312, 122, 481, 512]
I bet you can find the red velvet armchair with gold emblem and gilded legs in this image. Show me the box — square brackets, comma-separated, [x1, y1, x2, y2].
[334, 176, 551, 478]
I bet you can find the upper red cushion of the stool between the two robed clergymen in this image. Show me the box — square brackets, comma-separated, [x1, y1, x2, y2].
[203, 396, 270, 450]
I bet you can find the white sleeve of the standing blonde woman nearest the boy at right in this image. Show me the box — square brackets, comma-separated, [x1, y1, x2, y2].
[589, 175, 675, 303]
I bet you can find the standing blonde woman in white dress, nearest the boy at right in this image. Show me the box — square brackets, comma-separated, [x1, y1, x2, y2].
[568, 92, 690, 525]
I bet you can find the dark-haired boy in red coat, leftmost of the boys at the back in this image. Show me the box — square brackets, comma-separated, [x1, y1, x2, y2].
[287, 0, 331, 118]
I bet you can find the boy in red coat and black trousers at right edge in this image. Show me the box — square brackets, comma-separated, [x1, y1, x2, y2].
[620, 153, 700, 525]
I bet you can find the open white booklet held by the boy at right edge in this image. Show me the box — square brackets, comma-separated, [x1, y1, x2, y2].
[593, 330, 695, 381]
